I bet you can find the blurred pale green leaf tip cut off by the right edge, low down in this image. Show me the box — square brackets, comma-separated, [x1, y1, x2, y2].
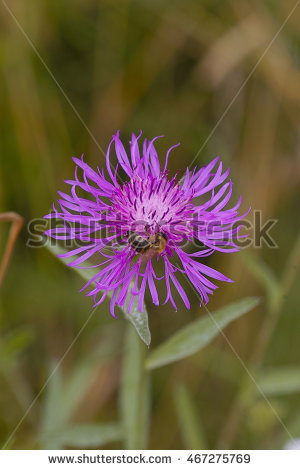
[257, 367, 300, 395]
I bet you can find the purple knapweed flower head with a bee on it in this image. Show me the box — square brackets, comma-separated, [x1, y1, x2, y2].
[45, 132, 245, 316]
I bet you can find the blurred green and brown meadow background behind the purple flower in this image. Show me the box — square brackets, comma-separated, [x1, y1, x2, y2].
[0, 0, 300, 449]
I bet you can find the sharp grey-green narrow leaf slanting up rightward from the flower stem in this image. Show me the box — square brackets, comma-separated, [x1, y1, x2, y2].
[146, 297, 260, 369]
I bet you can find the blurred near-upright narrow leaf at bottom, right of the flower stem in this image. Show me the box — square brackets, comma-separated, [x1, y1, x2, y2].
[174, 383, 207, 450]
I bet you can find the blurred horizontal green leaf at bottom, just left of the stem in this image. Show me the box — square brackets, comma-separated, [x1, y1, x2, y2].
[43, 423, 123, 448]
